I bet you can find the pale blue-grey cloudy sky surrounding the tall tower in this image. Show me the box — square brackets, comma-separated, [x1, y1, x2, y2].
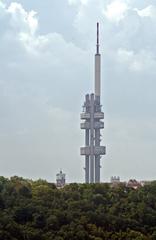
[0, 0, 156, 182]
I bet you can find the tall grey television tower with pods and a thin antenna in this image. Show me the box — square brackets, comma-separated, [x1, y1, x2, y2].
[80, 23, 106, 183]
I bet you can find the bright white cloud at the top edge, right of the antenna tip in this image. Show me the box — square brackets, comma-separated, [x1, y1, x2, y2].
[103, 0, 128, 22]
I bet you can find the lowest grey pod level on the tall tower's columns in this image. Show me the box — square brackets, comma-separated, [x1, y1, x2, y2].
[80, 146, 106, 156]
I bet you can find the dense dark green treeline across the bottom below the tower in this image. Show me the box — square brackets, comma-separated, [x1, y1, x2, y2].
[0, 177, 156, 240]
